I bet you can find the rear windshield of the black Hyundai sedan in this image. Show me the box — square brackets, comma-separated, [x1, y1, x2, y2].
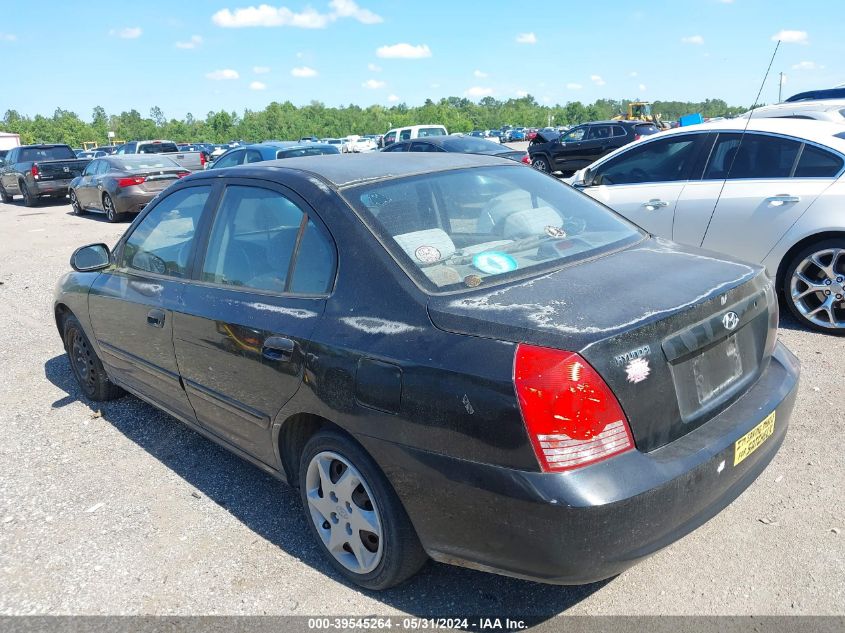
[343, 166, 642, 292]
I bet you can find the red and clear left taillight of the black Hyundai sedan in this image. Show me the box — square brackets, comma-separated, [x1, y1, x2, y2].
[513, 344, 634, 472]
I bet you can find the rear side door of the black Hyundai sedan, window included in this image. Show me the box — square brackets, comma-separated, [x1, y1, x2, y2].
[173, 179, 336, 463]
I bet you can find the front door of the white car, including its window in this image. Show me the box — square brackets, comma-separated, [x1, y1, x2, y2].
[584, 134, 707, 239]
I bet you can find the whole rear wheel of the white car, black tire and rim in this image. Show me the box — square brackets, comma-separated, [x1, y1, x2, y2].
[781, 237, 845, 336]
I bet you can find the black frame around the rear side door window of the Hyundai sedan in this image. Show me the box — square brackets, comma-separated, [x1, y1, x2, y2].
[190, 176, 340, 299]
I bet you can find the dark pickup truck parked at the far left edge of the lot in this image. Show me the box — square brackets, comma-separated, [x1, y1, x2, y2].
[0, 145, 91, 207]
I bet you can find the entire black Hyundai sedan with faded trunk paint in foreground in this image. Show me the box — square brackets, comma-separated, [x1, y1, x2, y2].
[55, 153, 798, 589]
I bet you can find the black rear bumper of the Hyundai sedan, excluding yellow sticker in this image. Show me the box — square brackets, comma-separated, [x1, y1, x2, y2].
[359, 344, 799, 584]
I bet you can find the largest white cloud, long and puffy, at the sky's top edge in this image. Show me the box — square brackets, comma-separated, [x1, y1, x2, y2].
[211, 0, 384, 29]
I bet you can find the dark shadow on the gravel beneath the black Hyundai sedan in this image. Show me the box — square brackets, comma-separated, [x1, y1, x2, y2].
[44, 355, 610, 624]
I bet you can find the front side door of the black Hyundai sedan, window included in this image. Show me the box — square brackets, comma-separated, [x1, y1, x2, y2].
[88, 185, 211, 421]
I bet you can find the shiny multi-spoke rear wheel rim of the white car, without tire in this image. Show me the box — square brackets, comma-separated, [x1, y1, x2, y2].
[789, 248, 845, 330]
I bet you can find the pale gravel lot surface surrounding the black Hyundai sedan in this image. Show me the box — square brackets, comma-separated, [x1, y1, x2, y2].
[0, 194, 845, 622]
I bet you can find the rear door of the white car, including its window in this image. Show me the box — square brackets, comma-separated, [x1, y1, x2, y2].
[701, 133, 842, 262]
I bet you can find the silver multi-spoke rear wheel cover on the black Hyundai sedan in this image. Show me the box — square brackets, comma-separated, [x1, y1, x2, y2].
[305, 451, 384, 574]
